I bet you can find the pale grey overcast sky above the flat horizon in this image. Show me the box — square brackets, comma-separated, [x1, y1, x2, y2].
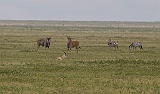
[0, 0, 160, 22]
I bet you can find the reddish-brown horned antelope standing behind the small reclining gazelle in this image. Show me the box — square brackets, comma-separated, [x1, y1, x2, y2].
[67, 36, 80, 53]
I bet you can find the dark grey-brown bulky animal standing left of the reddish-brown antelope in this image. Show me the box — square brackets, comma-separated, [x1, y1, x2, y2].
[37, 38, 51, 49]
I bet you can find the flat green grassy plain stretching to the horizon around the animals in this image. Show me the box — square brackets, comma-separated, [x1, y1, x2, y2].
[0, 21, 160, 94]
